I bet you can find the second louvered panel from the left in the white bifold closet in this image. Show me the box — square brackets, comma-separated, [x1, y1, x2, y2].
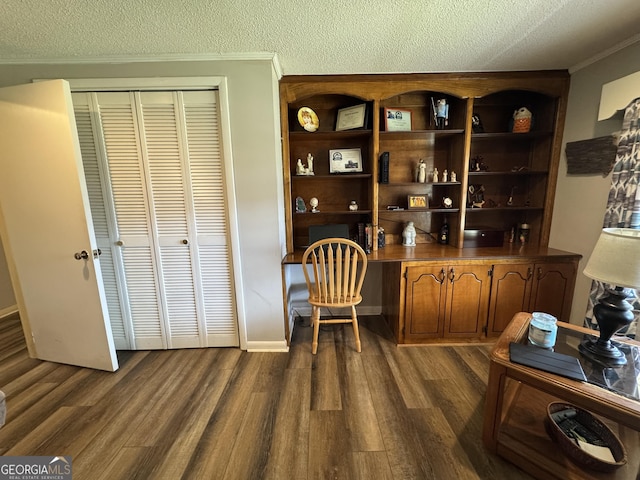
[91, 92, 168, 350]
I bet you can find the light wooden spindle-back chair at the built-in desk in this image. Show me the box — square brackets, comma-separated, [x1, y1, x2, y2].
[302, 238, 367, 355]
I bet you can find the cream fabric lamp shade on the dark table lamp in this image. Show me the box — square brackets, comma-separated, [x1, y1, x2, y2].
[583, 228, 640, 288]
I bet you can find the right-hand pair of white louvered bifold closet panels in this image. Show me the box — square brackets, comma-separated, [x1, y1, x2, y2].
[138, 91, 239, 348]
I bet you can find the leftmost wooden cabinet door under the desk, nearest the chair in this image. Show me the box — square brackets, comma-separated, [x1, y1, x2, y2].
[404, 265, 448, 343]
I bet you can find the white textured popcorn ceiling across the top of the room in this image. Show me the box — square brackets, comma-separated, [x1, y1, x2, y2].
[0, 0, 640, 75]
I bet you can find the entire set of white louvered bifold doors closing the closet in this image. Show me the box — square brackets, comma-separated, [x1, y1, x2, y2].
[74, 91, 239, 349]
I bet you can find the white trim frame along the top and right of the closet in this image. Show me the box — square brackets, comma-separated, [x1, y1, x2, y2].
[67, 77, 247, 350]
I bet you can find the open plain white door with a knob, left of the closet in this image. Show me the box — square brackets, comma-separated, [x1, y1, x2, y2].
[0, 80, 118, 371]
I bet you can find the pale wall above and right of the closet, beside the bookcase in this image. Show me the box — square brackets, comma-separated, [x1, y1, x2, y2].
[0, 59, 286, 349]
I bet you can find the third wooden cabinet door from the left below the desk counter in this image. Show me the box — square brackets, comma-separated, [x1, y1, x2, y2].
[487, 263, 534, 336]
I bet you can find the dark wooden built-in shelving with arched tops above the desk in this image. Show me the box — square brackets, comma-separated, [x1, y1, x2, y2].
[280, 71, 569, 253]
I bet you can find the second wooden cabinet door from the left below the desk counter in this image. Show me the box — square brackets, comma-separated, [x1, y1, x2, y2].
[444, 265, 491, 337]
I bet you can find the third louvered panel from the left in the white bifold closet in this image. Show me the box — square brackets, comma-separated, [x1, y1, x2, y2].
[136, 92, 206, 348]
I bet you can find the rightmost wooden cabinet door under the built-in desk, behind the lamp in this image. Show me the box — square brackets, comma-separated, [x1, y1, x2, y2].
[528, 263, 577, 322]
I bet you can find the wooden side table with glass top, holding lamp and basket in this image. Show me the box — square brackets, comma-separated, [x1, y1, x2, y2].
[482, 312, 640, 480]
